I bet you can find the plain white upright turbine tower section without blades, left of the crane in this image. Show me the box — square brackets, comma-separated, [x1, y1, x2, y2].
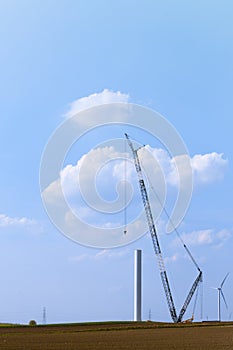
[134, 250, 142, 322]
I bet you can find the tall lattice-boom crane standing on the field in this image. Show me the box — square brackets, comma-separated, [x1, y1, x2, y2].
[125, 134, 202, 323]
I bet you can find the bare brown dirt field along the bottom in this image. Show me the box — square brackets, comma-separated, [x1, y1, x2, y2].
[0, 322, 233, 350]
